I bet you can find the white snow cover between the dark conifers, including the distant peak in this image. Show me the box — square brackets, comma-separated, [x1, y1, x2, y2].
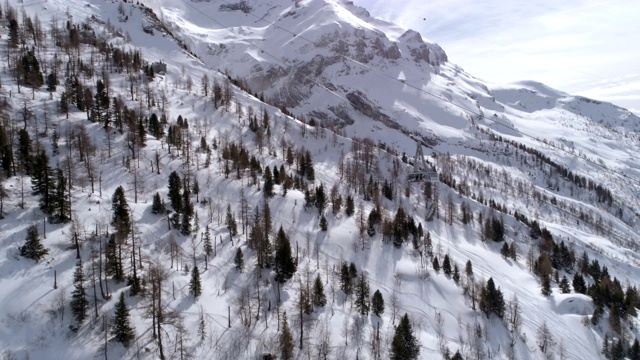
[0, 0, 640, 359]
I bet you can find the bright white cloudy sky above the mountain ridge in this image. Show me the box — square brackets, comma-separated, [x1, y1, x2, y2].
[354, 0, 640, 114]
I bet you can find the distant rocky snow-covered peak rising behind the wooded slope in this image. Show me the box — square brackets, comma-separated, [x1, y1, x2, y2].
[151, 0, 640, 196]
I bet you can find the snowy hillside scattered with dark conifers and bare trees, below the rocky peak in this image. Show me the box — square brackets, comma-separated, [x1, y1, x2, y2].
[0, 0, 640, 360]
